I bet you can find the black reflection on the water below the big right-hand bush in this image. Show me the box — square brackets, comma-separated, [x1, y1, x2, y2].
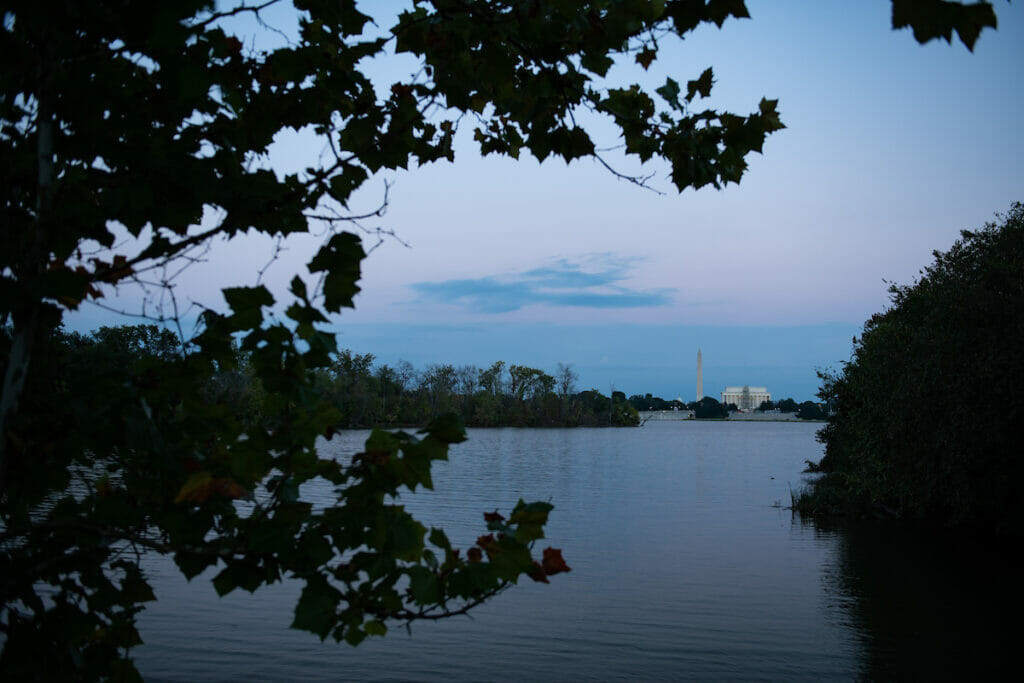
[817, 523, 1024, 681]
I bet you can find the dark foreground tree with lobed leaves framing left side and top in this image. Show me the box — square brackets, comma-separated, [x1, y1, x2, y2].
[0, 0, 994, 679]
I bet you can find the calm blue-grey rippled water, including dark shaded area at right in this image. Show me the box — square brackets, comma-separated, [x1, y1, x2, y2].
[135, 422, 1022, 681]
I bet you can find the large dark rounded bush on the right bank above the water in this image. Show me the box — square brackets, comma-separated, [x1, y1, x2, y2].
[803, 204, 1024, 532]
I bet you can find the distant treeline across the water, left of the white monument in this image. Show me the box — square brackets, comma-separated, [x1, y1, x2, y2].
[44, 325, 639, 429]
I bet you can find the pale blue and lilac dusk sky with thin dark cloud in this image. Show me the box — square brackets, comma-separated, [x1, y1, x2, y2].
[70, 0, 1024, 400]
